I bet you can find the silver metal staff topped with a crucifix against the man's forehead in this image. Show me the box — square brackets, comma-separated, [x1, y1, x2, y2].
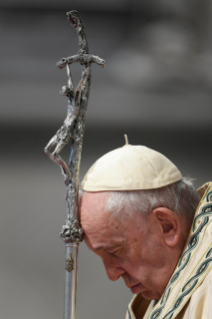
[45, 11, 105, 319]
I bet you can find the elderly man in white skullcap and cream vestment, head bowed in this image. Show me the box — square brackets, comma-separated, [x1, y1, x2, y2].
[80, 142, 212, 319]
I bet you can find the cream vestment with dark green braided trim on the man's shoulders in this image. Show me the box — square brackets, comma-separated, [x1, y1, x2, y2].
[126, 183, 212, 319]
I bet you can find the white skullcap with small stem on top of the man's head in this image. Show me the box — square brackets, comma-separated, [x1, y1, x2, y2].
[81, 139, 182, 192]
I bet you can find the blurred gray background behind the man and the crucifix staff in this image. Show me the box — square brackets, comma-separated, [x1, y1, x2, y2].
[0, 0, 212, 319]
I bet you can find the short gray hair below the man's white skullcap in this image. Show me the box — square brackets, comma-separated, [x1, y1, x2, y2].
[106, 177, 200, 223]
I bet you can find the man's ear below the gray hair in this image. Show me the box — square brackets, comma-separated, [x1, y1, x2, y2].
[153, 207, 181, 247]
